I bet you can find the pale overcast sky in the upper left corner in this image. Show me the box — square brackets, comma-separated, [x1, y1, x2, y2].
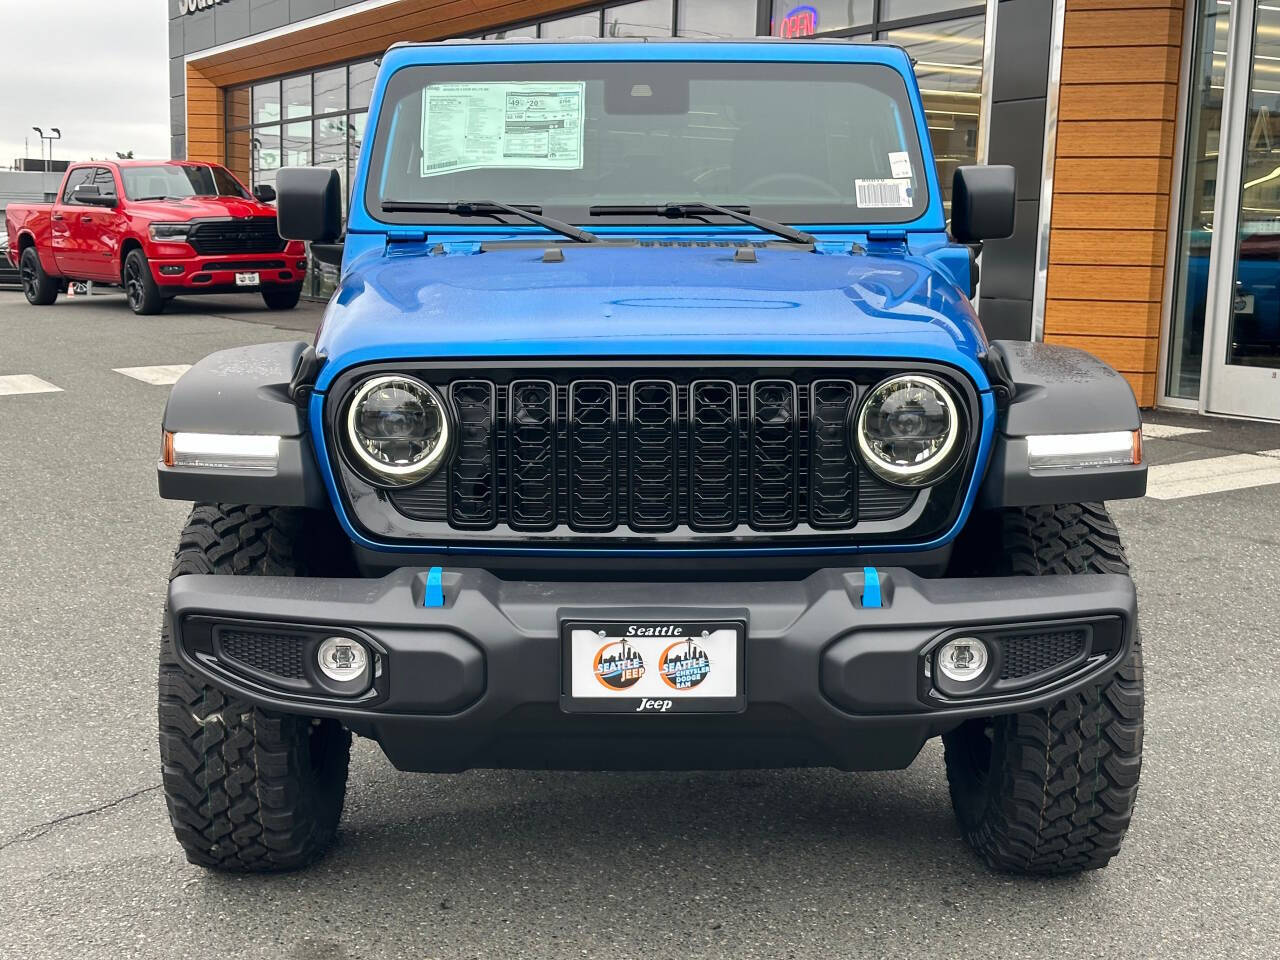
[0, 0, 173, 168]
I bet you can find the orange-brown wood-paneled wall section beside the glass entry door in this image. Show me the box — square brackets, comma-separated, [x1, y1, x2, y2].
[1044, 0, 1183, 407]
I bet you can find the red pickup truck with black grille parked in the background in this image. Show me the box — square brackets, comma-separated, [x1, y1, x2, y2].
[5, 160, 307, 314]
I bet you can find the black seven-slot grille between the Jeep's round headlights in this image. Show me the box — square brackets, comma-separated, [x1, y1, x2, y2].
[388, 375, 942, 534]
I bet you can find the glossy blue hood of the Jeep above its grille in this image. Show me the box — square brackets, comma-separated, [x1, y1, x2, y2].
[316, 243, 987, 390]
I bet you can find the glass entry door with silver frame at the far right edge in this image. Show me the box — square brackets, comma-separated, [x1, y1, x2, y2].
[1203, 0, 1280, 420]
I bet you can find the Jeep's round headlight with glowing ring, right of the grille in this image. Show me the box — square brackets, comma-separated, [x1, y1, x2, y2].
[852, 374, 961, 486]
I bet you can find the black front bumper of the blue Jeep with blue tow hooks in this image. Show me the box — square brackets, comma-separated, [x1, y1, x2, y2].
[169, 568, 1137, 771]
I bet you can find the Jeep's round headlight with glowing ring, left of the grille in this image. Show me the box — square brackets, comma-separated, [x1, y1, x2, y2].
[347, 376, 451, 485]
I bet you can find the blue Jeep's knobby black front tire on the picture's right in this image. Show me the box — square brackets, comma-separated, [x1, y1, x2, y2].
[942, 503, 1143, 874]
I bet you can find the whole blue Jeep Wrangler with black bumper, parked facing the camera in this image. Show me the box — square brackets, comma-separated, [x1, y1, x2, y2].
[159, 40, 1146, 873]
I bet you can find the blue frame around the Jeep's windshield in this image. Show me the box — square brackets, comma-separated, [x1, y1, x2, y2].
[360, 47, 946, 234]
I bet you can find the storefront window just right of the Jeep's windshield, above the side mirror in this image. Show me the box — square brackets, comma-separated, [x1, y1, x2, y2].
[881, 17, 984, 210]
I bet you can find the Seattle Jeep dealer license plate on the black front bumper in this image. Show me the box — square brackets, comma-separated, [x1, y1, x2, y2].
[561, 621, 746, 714]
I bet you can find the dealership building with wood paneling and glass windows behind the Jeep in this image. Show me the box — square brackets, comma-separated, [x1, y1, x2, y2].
[168, 0, 1280, 419]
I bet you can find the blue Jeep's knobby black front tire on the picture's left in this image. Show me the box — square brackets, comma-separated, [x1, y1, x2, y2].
[159, 503, 351, 873]
